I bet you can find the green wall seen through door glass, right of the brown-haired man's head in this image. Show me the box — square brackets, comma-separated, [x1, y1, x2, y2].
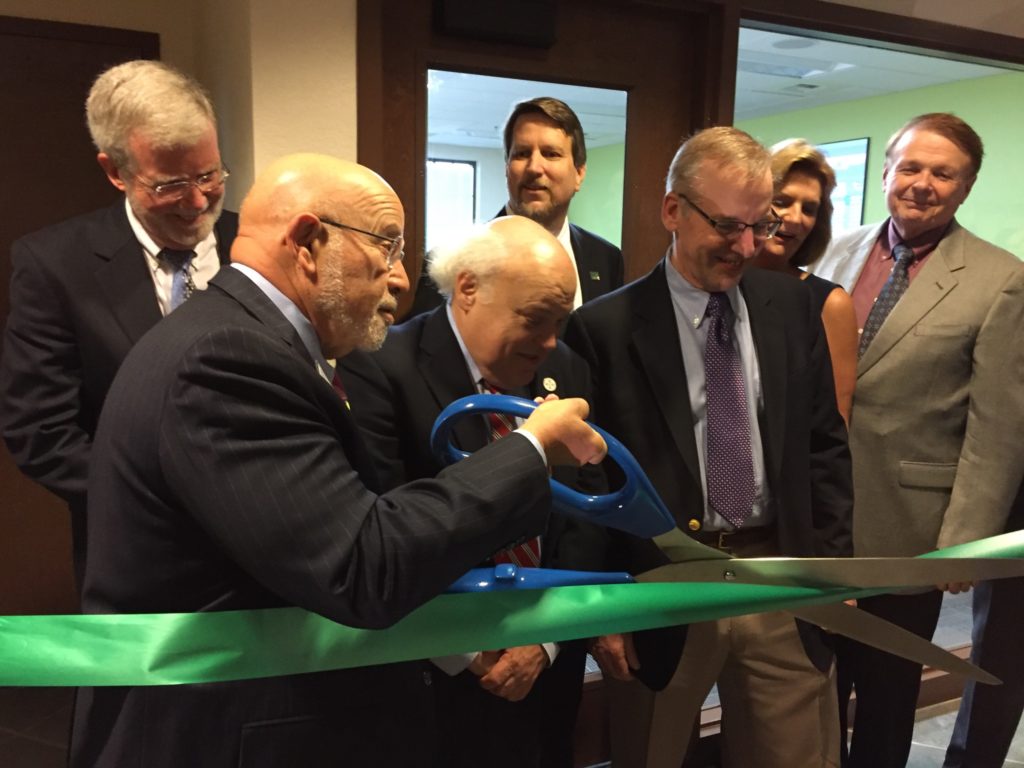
[569, 144, 626, 246]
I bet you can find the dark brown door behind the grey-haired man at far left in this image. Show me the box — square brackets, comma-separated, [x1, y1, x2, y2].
[0, 16, 159, 614]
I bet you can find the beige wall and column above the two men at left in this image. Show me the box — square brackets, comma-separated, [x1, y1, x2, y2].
[0, 0, 356, 207]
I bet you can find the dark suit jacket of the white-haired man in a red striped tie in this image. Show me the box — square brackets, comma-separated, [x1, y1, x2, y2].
[340, 306, 607, 766]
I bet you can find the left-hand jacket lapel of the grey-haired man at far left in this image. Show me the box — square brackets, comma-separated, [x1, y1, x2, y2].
[94, 200, 161, 344]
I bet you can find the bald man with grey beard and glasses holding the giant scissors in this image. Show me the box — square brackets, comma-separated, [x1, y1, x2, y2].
[71, 155, 604, 768]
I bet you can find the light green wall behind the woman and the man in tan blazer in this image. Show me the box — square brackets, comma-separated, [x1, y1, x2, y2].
[736, 73, 1024, 258]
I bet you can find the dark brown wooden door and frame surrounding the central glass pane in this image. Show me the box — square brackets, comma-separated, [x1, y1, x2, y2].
[357, 0, 735, 311]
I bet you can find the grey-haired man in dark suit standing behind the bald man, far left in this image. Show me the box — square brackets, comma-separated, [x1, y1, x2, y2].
[0, 60, 238, 586]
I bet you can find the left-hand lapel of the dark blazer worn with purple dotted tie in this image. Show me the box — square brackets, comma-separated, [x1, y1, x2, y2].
[632, 260, 701, 483]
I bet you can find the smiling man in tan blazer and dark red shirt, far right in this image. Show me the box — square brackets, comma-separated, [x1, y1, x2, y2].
[813, 113, 1024, 768]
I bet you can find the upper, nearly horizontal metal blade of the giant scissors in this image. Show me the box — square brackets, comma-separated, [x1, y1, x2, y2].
[638, 557, 1024, 589]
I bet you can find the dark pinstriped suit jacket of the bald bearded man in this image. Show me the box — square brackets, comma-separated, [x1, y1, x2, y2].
[72, 268, 550, 768]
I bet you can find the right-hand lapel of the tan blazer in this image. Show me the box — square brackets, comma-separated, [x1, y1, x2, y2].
[857, 222, 964, 377]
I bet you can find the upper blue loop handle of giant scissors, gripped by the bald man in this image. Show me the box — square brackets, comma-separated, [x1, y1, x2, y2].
[430, 394, 676, 539]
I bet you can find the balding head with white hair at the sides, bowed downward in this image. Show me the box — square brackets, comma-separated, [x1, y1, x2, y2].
[430, 216, 577, 389]
